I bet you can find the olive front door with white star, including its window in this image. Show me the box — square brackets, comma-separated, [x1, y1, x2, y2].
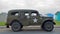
[30, 12, 40, 25]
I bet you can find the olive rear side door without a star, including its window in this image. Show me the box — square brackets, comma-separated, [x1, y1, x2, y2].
[20, 12, 30, 25]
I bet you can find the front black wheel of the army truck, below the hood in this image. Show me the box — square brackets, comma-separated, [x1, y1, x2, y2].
[42, 21, 54, 32]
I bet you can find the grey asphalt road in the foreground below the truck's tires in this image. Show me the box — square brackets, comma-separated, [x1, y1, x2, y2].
[0, 27, 60, 34]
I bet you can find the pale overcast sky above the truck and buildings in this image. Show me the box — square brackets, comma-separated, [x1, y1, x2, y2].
[0, 0, 60, 14]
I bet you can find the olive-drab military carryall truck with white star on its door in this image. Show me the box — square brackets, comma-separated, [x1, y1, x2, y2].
[6, 9, 55, 32]
